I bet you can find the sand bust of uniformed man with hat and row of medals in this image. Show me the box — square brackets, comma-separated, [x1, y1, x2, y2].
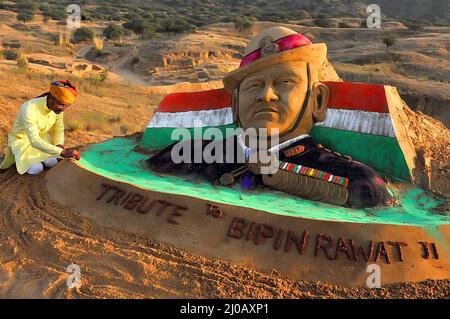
[149, 27, 392, 207]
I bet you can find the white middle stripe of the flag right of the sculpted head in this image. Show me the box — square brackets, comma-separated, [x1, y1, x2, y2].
[315, 109, 395, 137]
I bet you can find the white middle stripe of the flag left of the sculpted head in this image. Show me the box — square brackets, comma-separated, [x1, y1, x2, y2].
[147, 107, 233, 128]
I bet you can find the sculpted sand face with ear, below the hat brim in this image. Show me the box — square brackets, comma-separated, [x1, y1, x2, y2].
[238, 62, 328, 139]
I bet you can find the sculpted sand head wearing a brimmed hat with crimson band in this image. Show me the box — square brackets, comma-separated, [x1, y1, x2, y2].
[223, 27, 339, 142]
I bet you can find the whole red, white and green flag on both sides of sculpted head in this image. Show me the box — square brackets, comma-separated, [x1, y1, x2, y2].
[139, 82, 411, 180]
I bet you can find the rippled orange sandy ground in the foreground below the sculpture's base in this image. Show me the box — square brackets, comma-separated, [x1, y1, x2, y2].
[0, 168, 450, 298]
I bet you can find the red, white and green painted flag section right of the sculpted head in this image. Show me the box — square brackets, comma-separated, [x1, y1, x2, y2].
[311, 82, 412, 180]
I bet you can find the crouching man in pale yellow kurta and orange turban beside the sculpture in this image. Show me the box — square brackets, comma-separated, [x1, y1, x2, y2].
[0, 81, 80, 175]
